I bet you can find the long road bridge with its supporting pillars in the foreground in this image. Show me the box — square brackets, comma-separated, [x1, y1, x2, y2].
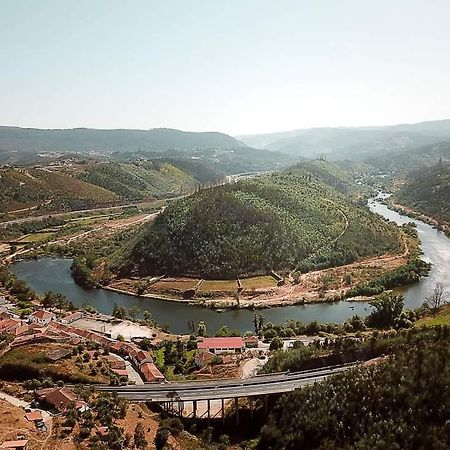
[95, 363, 357, 422]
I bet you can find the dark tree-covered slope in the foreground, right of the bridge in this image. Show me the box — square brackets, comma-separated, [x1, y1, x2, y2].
[257, 326, 450, 450]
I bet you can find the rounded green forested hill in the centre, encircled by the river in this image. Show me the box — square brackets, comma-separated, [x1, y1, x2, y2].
[110, 168, 399, 278]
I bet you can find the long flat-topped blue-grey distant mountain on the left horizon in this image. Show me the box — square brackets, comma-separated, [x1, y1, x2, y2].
[0, 127, 246, 152]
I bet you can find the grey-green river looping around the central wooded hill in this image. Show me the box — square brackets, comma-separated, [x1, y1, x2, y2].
[12, 200, 450, 333]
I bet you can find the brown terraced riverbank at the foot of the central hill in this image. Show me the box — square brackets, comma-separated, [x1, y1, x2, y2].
[103, 234, 419, 310]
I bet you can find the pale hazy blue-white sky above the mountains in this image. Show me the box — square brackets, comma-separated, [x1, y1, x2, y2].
[0, 0, 450, 134]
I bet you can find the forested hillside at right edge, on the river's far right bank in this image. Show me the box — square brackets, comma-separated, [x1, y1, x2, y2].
[395, 162, 450, 222]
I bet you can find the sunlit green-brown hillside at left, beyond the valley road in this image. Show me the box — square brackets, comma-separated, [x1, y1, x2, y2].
[0, 159, 223, 213]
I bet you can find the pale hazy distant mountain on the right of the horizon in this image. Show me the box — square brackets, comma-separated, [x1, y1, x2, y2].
[238, 120, 450, 161]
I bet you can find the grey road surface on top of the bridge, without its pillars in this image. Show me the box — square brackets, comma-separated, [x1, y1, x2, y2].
[95, 364, 355, 403]
